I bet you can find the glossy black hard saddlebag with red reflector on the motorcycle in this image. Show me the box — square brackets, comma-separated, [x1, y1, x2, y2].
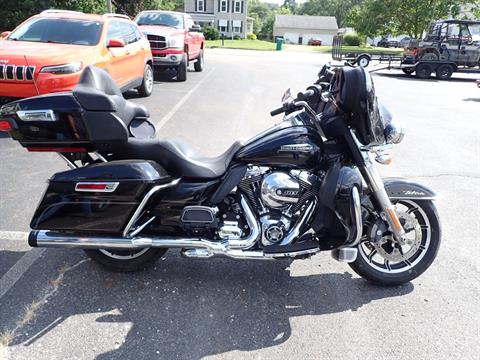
[30, 160, 171, 234]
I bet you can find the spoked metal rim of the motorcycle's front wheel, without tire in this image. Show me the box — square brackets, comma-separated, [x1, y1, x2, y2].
[358, 200, 432, 274]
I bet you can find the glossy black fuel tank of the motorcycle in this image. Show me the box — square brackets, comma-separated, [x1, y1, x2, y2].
[236, 123, 322, 169]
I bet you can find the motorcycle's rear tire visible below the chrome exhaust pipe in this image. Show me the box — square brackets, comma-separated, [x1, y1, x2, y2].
[85, 248, 167, 272]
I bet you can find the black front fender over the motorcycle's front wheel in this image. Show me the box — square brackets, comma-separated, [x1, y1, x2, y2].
[383, 178, 437, 200]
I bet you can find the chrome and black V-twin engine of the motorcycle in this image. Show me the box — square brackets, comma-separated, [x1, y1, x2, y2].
[238, 167, 319, 246]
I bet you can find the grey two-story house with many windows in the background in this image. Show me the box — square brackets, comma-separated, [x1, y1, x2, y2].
[184, 0, 253, 39]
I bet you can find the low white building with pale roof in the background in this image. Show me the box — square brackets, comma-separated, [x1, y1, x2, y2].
[273, 15, 338, 45]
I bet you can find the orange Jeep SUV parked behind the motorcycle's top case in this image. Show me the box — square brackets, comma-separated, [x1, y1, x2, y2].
[0, 10, 153, 98]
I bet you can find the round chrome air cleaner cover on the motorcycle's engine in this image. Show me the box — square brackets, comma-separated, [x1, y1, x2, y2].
[260, 172, 300, 209]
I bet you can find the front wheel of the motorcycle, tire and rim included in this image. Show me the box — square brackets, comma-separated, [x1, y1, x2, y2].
[349, 200, 441, 286]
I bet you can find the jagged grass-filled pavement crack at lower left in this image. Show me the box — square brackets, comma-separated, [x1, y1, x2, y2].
[0, 259, 90, 359]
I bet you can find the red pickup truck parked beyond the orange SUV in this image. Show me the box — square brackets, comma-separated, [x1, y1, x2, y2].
[135, 10, 205, 81]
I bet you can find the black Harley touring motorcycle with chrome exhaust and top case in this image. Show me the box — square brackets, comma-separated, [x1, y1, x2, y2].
[0, 66, 441, 285]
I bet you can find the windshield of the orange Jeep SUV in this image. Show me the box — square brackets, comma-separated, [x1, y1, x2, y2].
[8, 18, 102, 46]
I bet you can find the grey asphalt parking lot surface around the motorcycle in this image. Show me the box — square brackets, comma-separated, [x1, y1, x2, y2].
[0, 50, 480, 359]
